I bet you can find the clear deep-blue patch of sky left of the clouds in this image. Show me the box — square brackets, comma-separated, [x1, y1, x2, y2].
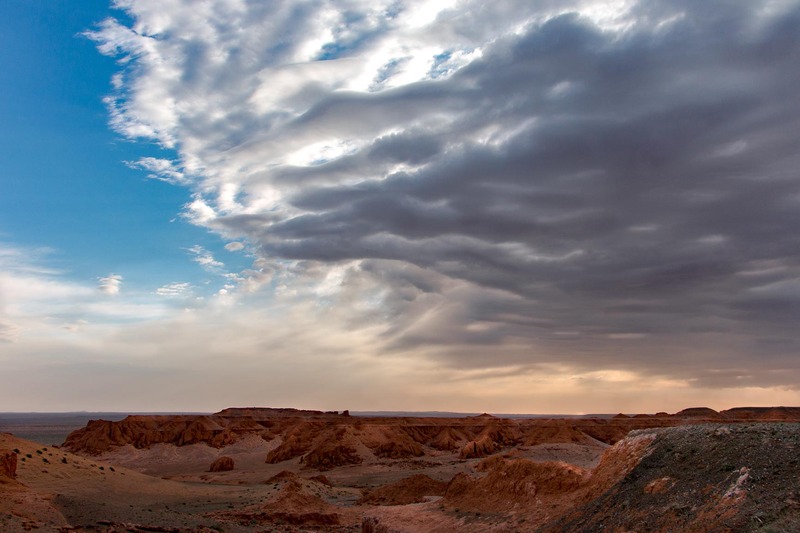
[0, 0, 238, 290]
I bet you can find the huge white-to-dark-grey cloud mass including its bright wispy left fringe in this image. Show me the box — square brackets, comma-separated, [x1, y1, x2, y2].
[90, 0, 800, 394]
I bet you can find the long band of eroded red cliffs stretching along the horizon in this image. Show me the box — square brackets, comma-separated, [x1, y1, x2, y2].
[64, 407, 800, 470]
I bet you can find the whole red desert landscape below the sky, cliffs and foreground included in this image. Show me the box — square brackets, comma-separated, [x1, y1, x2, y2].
[0, 407, 800, 533]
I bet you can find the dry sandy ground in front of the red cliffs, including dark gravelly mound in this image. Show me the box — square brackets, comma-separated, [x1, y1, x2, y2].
[0, 414, 800, 533]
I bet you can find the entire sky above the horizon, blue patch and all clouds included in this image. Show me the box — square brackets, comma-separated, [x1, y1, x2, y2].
[0, 0, 800, 414]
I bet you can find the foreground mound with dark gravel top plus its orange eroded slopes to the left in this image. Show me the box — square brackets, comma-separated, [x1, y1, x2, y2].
[364, 423, 800, 533]
